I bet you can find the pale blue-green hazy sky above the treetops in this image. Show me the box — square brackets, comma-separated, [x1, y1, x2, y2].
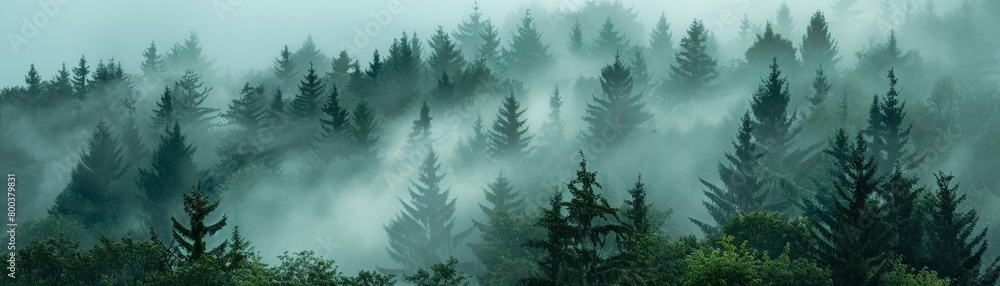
[0, 0, 951, 86]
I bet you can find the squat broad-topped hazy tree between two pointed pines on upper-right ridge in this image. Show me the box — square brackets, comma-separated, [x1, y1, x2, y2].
[745, 23, 798, 71]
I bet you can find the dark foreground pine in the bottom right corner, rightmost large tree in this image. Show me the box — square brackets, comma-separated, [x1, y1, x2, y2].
[927, 172, 1000, 285]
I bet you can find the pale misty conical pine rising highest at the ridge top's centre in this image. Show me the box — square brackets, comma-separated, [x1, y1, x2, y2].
[504, 10, 552, 79]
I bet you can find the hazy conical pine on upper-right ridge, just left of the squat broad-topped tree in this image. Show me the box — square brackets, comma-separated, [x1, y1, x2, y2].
[670, 20, 719, 93]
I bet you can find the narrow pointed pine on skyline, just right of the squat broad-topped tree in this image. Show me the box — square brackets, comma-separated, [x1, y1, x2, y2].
[799, 11, 840, 71]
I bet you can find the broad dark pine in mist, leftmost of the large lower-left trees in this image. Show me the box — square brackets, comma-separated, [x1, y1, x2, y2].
[51, 120, 124, 226]
